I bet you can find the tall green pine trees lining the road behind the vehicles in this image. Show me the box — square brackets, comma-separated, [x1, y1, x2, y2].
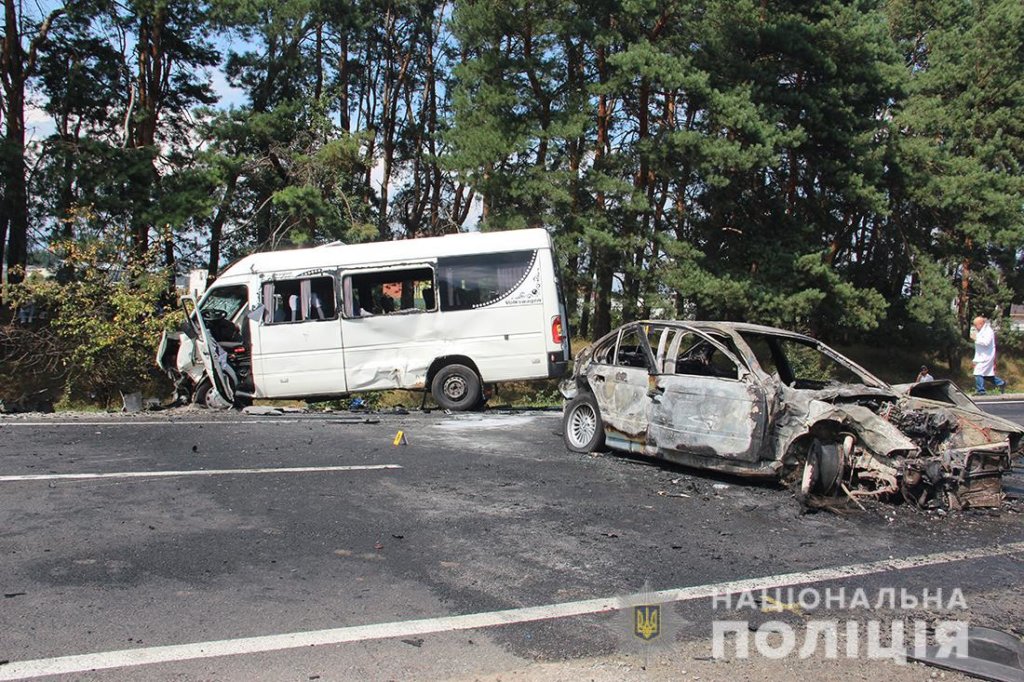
[6, 0, 1024, 405]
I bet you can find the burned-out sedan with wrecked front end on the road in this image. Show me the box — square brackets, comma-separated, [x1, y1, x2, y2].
[561, 321, 1024, 509]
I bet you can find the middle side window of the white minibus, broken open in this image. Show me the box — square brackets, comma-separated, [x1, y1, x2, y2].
[342, 267, 437, 317]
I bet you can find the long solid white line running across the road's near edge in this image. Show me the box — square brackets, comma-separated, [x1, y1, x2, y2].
[0, 542, 1024, 680]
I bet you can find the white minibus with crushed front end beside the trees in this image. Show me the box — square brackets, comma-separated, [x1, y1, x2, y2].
[158, 229, 569, 410]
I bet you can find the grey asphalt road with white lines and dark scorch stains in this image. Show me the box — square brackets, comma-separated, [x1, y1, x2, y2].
[0, 401, 1024, 680]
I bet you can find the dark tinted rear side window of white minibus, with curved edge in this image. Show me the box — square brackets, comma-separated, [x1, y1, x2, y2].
[437, 251, 537, 310]
